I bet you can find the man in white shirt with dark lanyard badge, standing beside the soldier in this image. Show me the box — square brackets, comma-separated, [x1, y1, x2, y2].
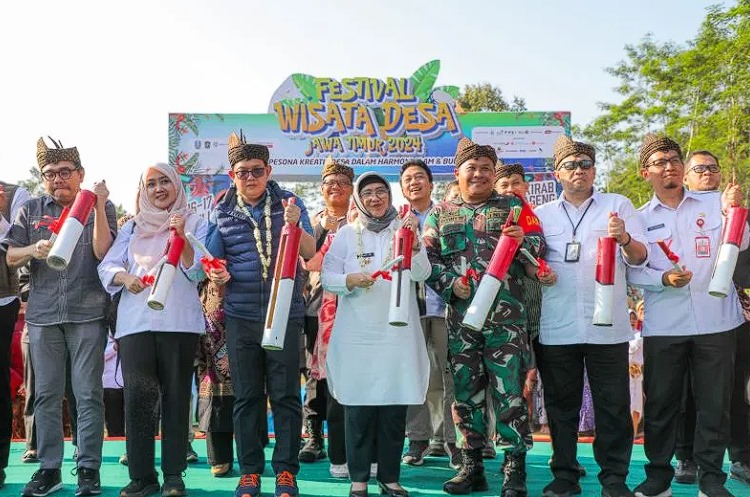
[534, 136, 647, 497]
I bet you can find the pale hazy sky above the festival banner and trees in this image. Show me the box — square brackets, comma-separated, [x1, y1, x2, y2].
[0, 0, 728, 210]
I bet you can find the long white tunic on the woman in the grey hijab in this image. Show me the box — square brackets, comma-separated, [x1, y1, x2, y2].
[321, 220, 431, 406]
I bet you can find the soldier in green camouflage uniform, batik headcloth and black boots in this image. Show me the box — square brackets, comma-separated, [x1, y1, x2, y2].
[423, 138, 546, 497]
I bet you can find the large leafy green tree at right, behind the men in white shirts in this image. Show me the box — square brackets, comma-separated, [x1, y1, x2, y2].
[583, 0, 750, 201]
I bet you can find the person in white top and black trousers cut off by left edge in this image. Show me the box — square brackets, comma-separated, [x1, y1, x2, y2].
[0, 181, 30, 488]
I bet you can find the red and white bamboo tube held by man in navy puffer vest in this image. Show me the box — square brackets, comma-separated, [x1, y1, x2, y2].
[261, 199, 302, 350]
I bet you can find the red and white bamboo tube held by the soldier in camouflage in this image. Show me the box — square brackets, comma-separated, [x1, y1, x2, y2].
[461, 209, 520, 331]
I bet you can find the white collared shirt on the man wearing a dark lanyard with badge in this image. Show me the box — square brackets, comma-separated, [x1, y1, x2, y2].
[534, 192, 646, 345]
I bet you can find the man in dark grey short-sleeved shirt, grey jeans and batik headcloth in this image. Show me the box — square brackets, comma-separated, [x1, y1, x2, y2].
[3, 138, 117, 497]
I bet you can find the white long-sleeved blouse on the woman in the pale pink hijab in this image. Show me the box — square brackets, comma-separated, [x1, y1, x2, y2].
[99, 218, 207, 339]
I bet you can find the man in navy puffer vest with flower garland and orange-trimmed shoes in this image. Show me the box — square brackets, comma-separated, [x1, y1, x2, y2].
[207, 133, 315, 497]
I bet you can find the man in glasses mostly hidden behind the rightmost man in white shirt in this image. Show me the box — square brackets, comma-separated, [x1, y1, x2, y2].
[674, 150, 750, 484]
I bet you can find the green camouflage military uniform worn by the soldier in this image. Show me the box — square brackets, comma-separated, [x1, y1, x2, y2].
[423, 192, 546, 452]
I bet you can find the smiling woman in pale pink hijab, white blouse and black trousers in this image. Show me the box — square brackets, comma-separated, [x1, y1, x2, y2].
[99, 164, 206, 497]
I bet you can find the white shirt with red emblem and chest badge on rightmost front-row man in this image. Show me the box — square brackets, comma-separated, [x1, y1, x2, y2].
[628, 190, 748, 337]
